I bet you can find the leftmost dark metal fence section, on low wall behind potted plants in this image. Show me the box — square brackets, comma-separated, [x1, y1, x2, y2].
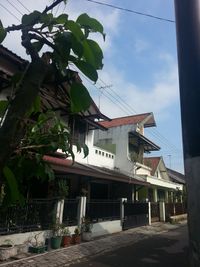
[0, 199, 58, 235]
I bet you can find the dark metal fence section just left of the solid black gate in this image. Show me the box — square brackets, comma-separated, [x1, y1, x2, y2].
[86, 200, 120, 222]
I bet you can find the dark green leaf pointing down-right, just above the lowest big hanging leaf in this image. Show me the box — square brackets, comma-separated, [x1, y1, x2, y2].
[74, 60, 98, 82]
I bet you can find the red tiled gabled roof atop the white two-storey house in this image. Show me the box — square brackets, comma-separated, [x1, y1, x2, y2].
[99, 113, 156, 128]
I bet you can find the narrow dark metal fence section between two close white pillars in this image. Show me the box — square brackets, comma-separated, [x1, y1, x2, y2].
[63, 199, 78, 226]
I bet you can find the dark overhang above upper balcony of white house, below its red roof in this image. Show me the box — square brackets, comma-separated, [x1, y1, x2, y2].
[129, 132, 160, 152]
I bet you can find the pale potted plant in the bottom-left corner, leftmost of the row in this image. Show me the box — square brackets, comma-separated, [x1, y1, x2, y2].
[0, 239, 17, 261]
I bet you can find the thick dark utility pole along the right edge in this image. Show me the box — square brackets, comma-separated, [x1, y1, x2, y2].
[174, 0, 200, 267]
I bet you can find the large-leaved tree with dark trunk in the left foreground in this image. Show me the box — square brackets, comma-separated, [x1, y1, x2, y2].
[0, 0, 105, 202]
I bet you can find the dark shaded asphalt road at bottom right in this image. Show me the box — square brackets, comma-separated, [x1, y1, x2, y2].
[70, 226, 189, 267]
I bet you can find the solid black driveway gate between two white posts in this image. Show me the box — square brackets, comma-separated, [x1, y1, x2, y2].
[123, 201, 149, 230]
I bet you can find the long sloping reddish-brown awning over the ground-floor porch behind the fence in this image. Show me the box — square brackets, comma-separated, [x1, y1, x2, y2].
[43, 156, 149, 186]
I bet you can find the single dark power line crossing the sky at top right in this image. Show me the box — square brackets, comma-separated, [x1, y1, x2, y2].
[86, 0, 175, 23]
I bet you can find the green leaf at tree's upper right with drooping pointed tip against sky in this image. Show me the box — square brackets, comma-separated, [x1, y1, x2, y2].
[76, 13, 105, 40]
